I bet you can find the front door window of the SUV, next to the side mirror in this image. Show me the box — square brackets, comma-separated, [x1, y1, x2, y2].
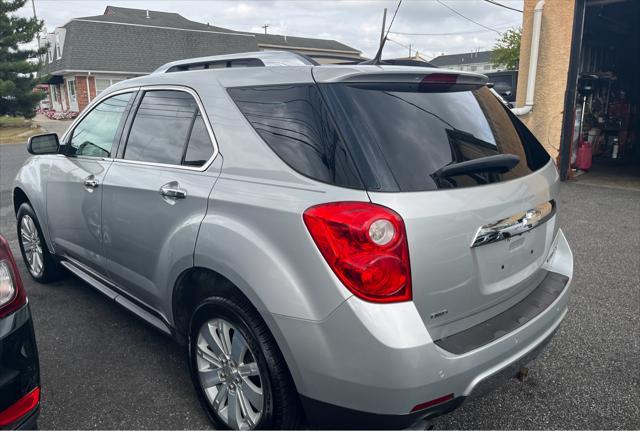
[67, 93, 133, 157]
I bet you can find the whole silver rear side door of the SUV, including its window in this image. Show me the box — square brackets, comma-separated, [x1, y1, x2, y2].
[102, 87, 219, 310]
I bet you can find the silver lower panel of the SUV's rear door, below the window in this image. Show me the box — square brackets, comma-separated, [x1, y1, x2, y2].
[102, 158, 222, 317]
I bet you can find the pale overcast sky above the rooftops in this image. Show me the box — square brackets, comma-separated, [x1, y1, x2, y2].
[19, 0, 523, 59]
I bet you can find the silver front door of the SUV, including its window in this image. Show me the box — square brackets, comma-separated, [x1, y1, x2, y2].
[46, 91, 135, 274]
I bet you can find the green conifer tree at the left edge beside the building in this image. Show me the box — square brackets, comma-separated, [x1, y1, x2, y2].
[0, 0, 46, 118]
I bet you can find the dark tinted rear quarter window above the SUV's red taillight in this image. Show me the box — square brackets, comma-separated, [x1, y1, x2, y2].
[229, 84, 362, 188]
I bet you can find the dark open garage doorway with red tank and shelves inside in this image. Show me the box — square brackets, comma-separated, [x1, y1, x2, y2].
[563, 0, 640, 189]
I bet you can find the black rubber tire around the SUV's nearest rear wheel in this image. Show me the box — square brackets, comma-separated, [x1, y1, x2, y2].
[189, 288, 303, 429]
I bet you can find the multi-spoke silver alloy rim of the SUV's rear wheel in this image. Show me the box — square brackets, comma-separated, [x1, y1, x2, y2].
[196, 318, 264, 429]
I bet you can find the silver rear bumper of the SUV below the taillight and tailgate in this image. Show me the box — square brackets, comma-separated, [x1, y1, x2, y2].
[274, 231, 573, 428]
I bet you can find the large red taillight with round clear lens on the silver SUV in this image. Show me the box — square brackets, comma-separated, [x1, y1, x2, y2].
[303, 202, 411, 302]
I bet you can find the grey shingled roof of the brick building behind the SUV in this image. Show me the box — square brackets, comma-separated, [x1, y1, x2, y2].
[44, 6, 360, 74]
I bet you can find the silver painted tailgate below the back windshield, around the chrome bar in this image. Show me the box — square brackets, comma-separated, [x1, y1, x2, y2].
[369, 161, 558, 339]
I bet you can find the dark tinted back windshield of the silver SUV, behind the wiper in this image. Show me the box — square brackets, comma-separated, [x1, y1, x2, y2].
[322, 84, 549, 191]
